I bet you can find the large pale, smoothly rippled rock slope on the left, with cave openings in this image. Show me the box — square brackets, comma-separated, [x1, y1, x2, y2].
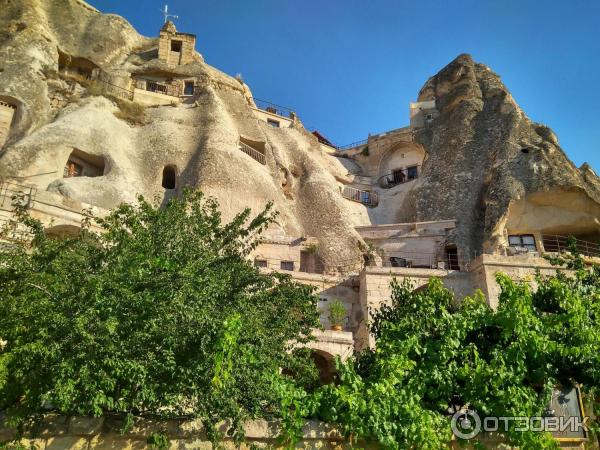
[0, 0, 360, 265]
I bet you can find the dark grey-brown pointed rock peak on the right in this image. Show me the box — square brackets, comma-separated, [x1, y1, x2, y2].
[401, 55, 600, 260]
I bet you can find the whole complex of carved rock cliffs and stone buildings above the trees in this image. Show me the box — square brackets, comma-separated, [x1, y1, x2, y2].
[0, 0, 600, 390]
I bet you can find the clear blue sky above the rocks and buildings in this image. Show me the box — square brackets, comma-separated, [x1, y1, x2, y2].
[95, 0, 600, 172]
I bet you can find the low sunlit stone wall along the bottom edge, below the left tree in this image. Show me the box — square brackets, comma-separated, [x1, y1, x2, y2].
[0, 415, 352, 450]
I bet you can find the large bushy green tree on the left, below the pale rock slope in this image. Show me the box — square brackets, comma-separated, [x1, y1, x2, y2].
[0, 191, 318, 438]
